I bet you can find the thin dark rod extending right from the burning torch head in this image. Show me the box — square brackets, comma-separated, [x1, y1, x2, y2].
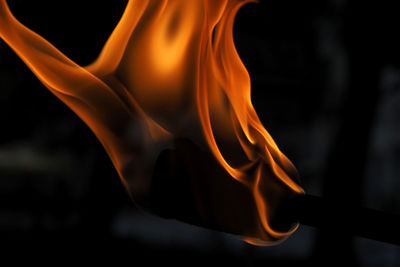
[283, 194, 400, 245]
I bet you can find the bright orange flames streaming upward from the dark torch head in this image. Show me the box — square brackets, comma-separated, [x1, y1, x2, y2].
[0, 0, 304, 245]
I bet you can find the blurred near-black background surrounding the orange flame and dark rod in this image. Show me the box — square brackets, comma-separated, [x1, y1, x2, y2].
[0, 0, 400, 266]
